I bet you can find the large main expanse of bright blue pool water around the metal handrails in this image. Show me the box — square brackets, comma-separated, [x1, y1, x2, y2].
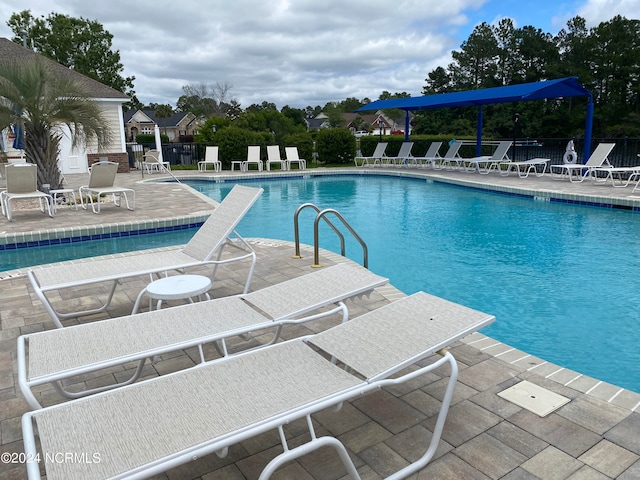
[188, 175, 640, 392]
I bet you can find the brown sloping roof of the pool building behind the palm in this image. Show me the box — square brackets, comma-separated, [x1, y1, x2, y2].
[0, 38, 129, 102]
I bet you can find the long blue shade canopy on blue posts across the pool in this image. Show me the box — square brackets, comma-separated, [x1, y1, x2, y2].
[356, 77, 593, 159]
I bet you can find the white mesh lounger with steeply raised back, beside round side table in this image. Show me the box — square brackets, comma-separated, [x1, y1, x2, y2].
[27, 186, 263, 328]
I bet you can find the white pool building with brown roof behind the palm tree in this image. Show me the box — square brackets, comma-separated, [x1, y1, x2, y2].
[0, 38, 130, 175]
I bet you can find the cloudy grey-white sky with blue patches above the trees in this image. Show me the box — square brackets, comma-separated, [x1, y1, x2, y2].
[0, 0, 640, 108]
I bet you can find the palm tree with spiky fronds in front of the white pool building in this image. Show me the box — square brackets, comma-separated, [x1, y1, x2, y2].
[0, 59, 111, 189]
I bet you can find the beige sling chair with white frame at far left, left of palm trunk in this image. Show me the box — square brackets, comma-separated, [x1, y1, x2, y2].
[0, 163, 54, 221]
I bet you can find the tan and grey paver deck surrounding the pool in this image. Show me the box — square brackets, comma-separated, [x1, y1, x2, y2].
[0, 168, 640, 480]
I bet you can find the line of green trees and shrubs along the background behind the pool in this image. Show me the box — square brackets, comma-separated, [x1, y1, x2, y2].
[7, 10, 640, 138]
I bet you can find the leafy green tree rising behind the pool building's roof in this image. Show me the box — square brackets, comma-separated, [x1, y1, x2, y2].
[7, 10, 137, 101]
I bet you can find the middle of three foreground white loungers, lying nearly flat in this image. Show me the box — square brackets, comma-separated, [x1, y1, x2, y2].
[18, 264, 388, 409]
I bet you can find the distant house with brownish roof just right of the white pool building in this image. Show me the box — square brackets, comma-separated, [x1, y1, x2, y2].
[124, 109, 199, 142]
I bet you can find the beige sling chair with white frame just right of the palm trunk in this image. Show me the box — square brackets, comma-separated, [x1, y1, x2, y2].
[78, 162, 136, 214]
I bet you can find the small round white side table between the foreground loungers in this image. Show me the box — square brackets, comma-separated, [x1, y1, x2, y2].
[131, 275, 211, 315]
